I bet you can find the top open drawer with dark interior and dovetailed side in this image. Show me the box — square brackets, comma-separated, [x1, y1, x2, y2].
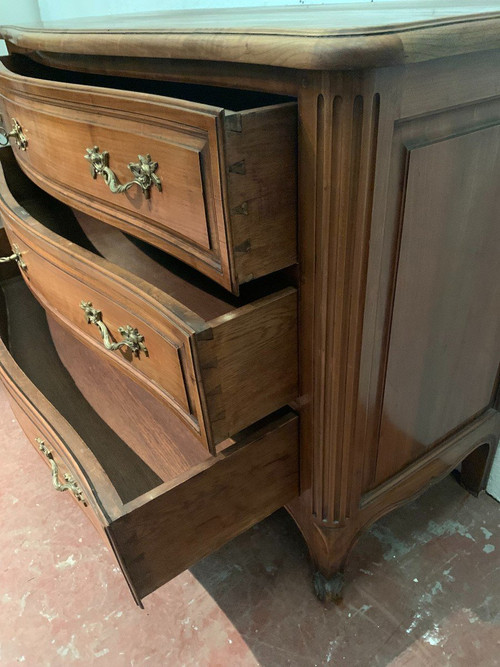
[0, 56, 297, 294]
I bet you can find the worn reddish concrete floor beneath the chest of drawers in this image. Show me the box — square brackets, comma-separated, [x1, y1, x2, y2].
[0, 390, 500, 667]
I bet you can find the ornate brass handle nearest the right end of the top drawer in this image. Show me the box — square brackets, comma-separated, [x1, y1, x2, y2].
[84, 146, 161, 199]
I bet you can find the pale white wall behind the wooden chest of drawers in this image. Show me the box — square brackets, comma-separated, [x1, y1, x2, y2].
[0, 0, 500, 501]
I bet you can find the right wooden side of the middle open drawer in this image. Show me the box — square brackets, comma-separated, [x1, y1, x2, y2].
[195, 287, 298, 442]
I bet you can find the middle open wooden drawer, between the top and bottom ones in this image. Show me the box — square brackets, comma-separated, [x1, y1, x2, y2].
[0, 149, 297, 453]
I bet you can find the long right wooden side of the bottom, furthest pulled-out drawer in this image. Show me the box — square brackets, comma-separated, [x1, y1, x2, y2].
[109, 412, 299, 598]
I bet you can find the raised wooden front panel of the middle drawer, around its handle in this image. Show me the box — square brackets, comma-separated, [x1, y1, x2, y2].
[6, 220, 203, 428]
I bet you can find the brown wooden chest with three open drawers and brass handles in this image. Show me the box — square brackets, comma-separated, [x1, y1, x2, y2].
[0, 3, 500, 603]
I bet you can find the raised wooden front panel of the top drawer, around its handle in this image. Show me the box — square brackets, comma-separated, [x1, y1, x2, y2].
[0, 90, 221, 252]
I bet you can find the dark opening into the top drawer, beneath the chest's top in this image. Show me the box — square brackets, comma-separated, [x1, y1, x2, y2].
[1, 54, 294, 111]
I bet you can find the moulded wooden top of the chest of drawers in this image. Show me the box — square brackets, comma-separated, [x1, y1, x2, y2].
[0, 0, 500, 69]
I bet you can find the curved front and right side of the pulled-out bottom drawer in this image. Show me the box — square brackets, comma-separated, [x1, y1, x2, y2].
[0, 277, 298, 604]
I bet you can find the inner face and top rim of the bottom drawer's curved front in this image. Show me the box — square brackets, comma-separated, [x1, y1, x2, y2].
[1, 277, 154, 517]
